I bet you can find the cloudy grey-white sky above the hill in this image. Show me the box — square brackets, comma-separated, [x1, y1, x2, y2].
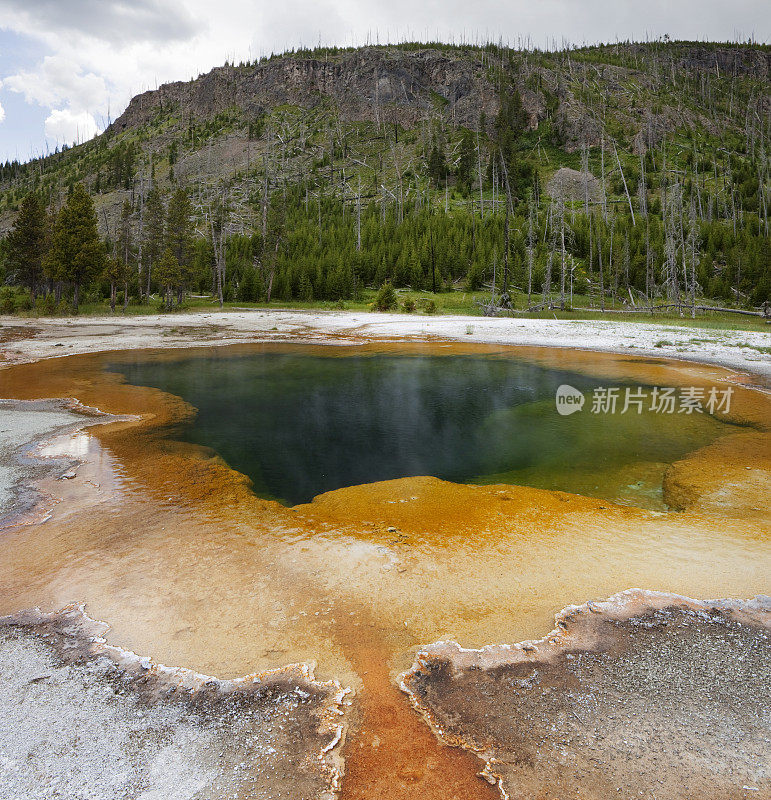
[0, 0, 771, 160]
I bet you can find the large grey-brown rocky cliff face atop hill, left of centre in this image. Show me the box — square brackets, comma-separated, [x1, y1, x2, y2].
[113, 48, 498, 132]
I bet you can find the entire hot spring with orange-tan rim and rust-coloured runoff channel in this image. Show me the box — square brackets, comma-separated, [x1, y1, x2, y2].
[0, 342, 771, 800]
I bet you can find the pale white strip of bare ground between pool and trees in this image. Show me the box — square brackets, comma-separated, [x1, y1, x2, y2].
[0, 309, 771, 380]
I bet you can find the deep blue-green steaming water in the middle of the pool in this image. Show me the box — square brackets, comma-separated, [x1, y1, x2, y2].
[108, 348, 725, 507]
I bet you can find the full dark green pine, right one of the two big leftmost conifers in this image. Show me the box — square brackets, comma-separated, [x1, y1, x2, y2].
[46, 183, 105, 311]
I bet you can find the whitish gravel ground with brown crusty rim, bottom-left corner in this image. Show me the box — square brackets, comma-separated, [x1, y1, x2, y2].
[0, 607, 346, 800]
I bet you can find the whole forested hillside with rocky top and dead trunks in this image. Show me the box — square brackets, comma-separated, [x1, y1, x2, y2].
[0, 41, 771, 311]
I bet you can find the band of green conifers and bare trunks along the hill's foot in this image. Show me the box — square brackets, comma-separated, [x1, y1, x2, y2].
[2, 167, 771, 310]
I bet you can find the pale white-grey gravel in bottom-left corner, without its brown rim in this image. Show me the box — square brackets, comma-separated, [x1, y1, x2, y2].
[0, 636, 219, 800]
